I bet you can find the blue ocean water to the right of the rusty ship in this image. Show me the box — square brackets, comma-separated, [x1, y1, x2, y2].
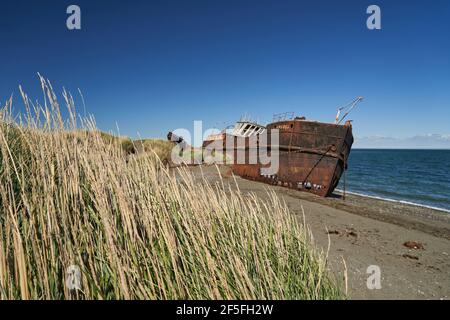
[337, 149, 450, 213]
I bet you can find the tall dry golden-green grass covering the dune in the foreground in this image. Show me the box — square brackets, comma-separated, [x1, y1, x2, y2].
[0, 79, 342, 299]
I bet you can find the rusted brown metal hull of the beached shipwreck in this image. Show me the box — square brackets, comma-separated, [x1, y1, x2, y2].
[204, 119, 353, 197]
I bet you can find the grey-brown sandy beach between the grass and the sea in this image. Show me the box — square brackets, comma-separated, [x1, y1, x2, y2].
[184, 166, 450, 299]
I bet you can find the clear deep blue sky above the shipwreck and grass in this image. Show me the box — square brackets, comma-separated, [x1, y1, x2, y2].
[0, 0, 450, 137]
